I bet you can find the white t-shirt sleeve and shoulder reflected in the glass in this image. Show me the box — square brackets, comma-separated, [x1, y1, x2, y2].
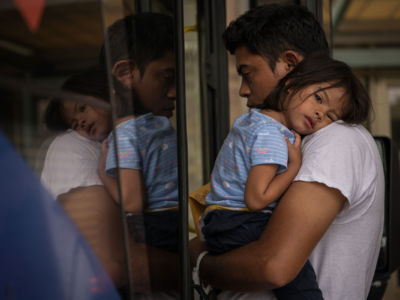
[41, 130, 103, 198]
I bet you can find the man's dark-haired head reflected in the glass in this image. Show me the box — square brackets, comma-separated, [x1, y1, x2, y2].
[100, 13, 176, 118]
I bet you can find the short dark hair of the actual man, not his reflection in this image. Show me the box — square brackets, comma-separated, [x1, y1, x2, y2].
[222, 4, 329, 71]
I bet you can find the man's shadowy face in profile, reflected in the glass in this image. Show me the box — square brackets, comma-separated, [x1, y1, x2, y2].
[131, 52, 176, 118]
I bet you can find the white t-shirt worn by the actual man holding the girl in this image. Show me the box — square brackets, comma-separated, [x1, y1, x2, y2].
[218, 122, 384, 300]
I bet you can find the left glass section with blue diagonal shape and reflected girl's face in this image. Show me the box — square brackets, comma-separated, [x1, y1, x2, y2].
[0, 0, 122, 299]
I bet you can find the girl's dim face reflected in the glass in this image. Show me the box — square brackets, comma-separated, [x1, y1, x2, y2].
[63, 97, 112, 142]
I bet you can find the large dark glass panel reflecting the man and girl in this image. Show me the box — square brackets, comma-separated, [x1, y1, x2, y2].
[0, 0, 181, 299]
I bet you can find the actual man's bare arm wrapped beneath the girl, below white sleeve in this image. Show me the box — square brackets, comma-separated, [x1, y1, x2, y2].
[191, 182, 346, 291]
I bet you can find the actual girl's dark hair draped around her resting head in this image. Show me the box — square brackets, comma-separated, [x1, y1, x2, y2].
[259, 52, 371, 124]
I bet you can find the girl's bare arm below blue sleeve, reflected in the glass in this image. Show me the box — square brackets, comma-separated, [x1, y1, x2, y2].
[98, 141, 145, 213]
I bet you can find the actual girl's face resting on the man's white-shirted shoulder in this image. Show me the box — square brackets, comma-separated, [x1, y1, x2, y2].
[283, 82, 347, 135]
